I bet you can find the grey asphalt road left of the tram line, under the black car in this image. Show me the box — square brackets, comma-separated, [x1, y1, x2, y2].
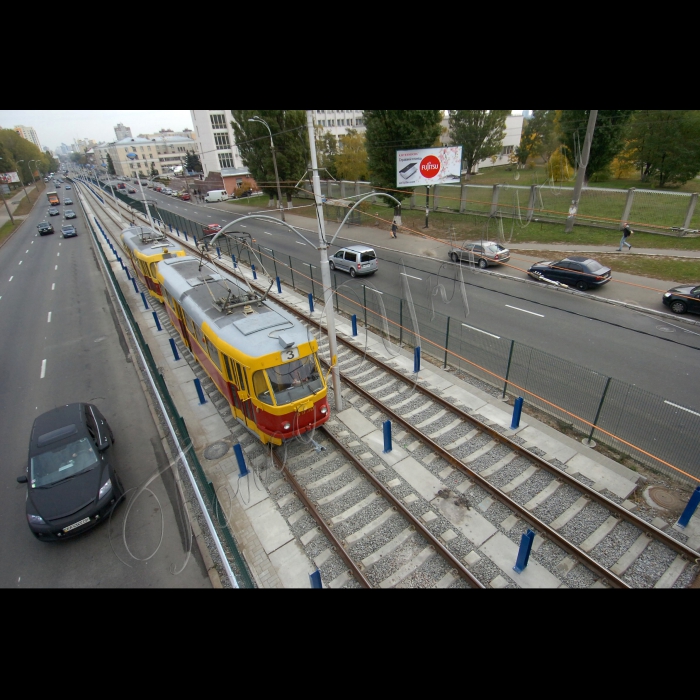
[0, 183, 210, 588]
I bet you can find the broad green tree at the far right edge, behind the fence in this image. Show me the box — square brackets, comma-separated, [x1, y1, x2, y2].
[629, 109, 700, 187]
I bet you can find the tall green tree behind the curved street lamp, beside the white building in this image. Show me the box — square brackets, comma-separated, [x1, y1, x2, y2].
[231, 109, 309, 203]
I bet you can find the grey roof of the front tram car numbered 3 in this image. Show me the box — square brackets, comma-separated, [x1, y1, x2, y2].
[159, 256, 311, 357]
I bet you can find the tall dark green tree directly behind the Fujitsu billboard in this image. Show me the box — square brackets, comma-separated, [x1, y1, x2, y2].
[364, 109, 442, 200]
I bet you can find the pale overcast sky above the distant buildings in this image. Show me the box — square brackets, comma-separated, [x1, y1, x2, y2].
[0, 109, 193, 150]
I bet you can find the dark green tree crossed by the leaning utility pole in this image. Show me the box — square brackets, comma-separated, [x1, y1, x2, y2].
[559, 109, 634, 182]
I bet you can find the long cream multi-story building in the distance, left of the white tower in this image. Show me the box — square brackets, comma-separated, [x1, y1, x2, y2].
[95, 136, 199, 177]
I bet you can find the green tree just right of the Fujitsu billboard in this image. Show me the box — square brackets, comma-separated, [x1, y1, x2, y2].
[449, 109, 512, 174]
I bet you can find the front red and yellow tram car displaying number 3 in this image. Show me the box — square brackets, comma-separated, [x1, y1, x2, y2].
[156, 256, 330, 445]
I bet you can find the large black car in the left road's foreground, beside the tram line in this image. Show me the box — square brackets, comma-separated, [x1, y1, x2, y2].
[17, 403, 124, 541]
